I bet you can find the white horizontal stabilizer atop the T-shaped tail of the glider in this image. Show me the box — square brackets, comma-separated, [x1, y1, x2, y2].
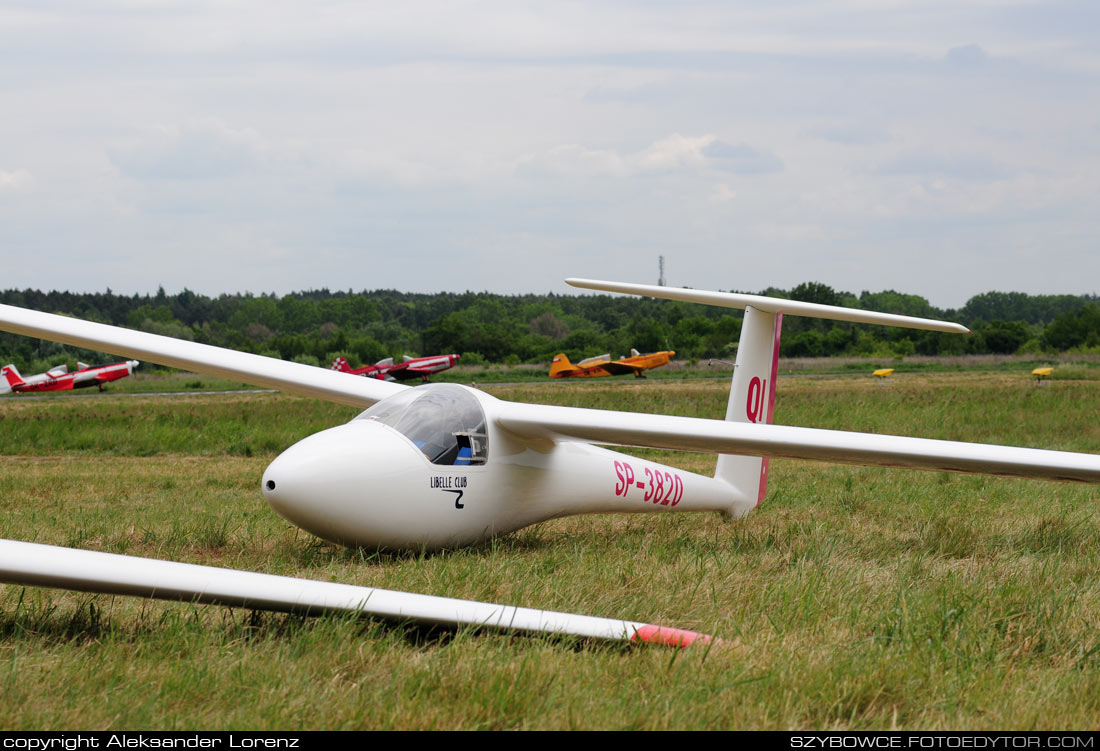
[565, 278, 970, 334]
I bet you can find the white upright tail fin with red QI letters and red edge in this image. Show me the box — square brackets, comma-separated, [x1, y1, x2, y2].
[714, 306, 783, 517]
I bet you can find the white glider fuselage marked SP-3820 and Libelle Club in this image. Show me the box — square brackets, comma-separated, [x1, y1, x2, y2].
[262, 384, 739, 549]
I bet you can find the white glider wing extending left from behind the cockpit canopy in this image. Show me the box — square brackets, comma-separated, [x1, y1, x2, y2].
[0, 305, 408, 407]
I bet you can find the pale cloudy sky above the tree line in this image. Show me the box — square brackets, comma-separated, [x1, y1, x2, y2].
[0, 0, 1100, 308]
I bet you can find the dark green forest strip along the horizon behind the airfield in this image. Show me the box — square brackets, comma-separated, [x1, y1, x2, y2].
[0, 281, 1100, 373]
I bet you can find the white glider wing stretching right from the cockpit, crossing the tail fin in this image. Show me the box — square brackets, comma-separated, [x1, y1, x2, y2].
[497, 402, 1100, 483]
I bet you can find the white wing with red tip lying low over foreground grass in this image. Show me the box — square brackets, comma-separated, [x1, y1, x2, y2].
[0, 540, 711, 647]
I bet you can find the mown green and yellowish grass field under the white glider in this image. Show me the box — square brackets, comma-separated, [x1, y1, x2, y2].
[0, 373, 1100, 730]
